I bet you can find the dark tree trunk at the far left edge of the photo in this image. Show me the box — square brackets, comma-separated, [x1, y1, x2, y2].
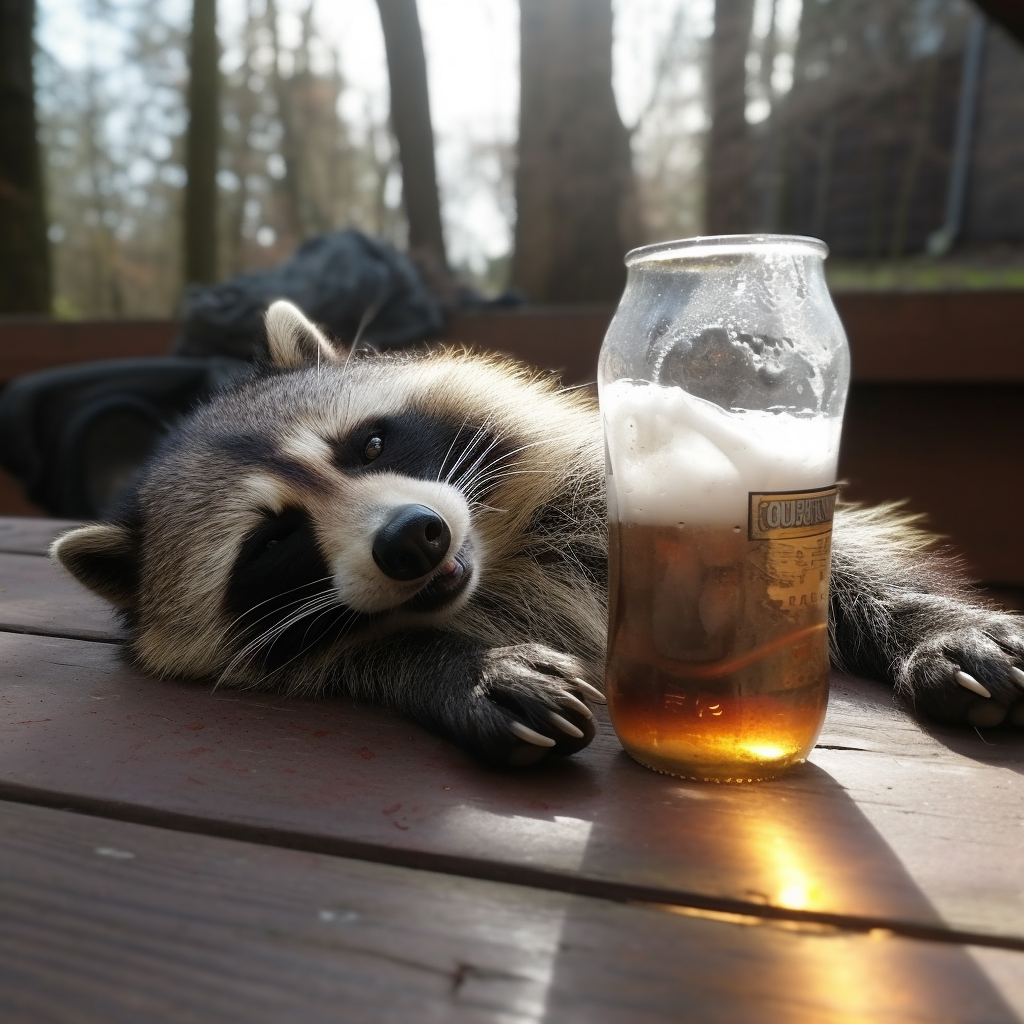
[0, 0, 50, 313]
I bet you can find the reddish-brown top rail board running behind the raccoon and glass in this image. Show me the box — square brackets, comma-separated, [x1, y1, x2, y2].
[6, 291, 1024, 383]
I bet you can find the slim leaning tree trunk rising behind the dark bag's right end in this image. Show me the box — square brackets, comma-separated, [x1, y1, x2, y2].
[377, 0, 447, 268]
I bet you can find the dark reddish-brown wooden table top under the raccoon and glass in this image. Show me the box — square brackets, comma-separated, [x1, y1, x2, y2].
[0, 518, 1024, 1024]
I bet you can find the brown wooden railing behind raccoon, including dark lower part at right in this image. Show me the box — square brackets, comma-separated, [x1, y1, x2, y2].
[0, 292, 1024, 587]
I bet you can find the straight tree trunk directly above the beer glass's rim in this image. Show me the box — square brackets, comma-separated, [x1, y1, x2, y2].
[706, 0, 754, 234]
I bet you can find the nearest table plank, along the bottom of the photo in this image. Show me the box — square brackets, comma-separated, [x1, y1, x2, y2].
[0, 805, 1024, 1024]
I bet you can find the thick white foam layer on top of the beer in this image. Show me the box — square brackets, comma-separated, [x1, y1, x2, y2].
[601, 380, 840, 526]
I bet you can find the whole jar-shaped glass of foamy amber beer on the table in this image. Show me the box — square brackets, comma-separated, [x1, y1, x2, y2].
[598, 234, 849, 782]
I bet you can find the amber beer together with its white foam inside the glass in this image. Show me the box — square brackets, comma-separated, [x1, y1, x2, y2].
[602, 381, 838, 781]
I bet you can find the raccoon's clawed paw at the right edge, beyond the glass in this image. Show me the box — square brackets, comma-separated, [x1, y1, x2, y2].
[897, 609, 1024, 728]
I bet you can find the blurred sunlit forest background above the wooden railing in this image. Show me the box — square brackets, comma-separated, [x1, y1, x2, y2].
[0, 0, 1024, 318]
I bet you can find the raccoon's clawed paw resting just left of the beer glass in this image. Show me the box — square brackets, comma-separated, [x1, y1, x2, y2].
[465, 644, 604, 767]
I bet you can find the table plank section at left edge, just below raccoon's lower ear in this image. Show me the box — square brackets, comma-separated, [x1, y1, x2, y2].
[0, 553, 121, 641]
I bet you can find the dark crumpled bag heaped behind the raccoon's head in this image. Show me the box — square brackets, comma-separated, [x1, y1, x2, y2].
[0, 230, 443, 519]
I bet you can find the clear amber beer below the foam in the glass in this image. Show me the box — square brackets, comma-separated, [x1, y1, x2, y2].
[606, 487, 836, 782]
